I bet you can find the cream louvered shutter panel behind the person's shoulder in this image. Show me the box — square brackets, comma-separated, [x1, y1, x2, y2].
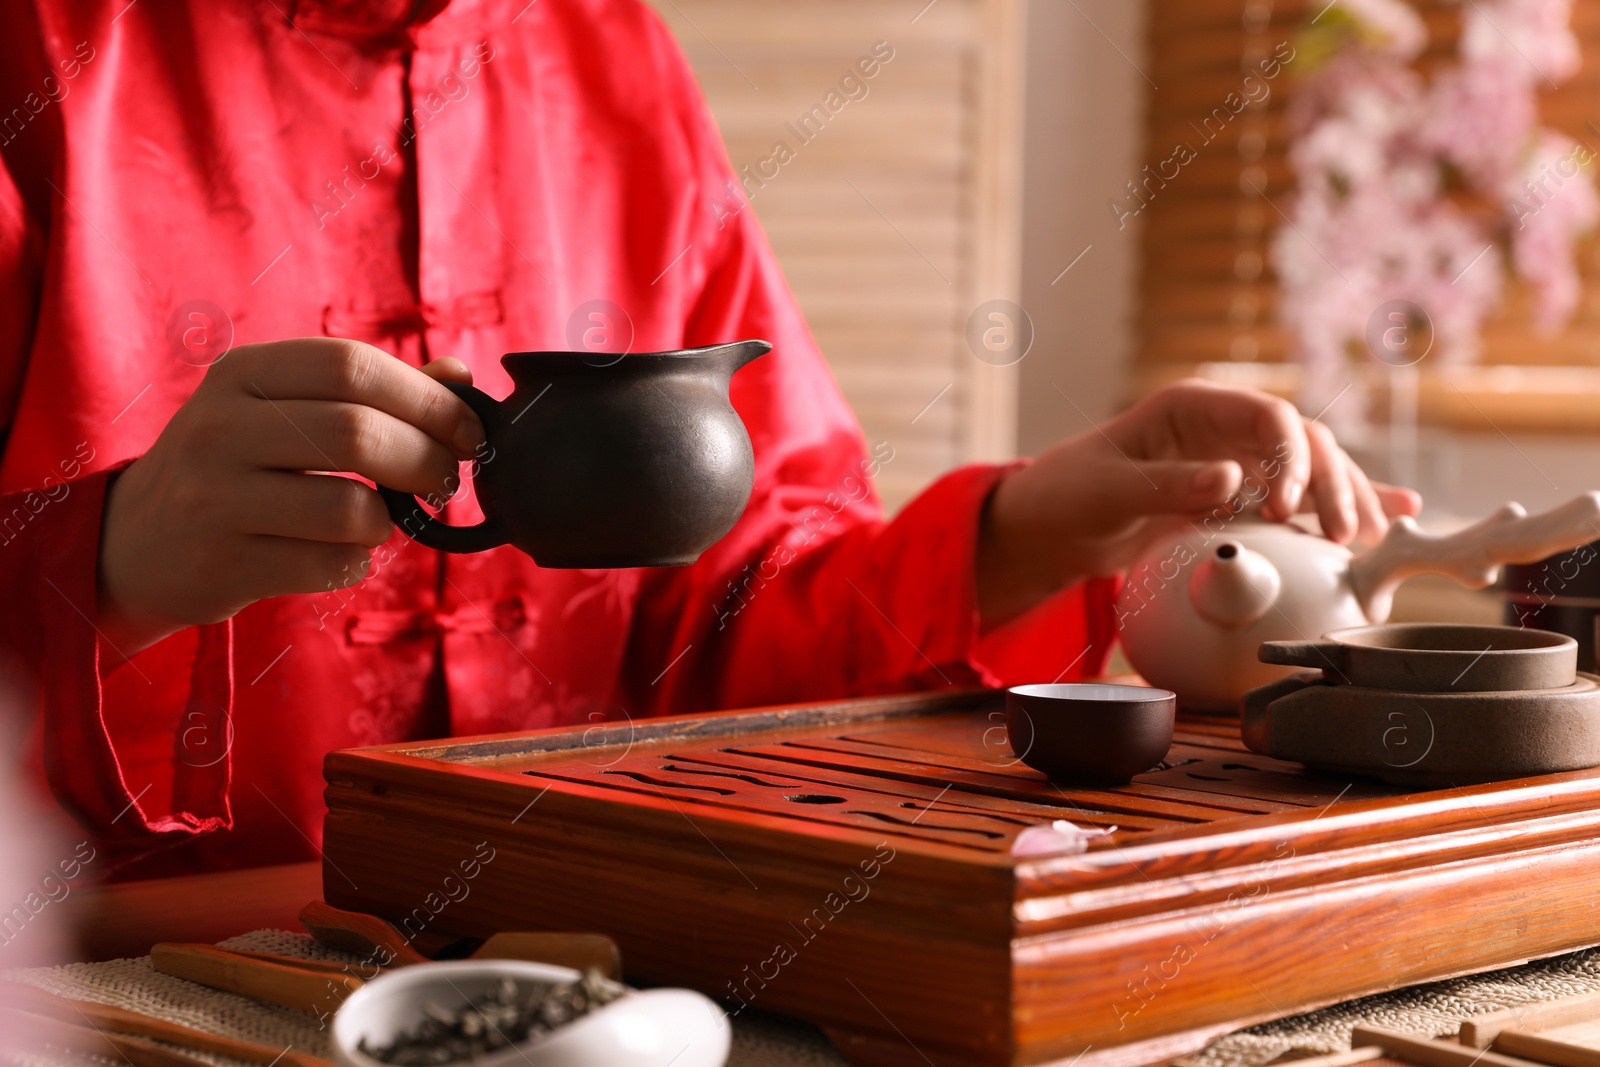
[640, 0, 1022, 507]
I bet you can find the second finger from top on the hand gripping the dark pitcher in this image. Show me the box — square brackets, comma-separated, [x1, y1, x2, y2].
[234, 400, 461, 501]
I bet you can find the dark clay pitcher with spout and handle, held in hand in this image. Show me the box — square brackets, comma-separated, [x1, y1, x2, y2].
[378, 341, 773, 568]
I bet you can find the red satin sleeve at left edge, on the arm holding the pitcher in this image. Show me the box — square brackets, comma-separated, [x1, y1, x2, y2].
[0, 133, 232, 857]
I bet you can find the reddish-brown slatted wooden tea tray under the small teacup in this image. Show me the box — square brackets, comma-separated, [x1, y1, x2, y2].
[323, 693, 1600, 1067]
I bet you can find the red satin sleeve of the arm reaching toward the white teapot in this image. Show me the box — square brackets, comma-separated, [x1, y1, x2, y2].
[624, 27, 1115, 712]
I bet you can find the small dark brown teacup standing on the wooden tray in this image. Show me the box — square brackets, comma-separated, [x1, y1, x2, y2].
[1005, 681, 1178, 785]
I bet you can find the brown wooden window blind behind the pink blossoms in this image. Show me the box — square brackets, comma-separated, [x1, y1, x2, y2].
[1139, 0, 1600, 434]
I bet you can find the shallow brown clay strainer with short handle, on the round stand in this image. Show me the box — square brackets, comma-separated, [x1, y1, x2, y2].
[1261, 622, 1578, 693]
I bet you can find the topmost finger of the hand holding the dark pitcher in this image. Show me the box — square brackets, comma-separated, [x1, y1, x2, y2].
[216, 338, 483, 459]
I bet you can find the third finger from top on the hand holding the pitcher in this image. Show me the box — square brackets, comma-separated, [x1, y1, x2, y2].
[237, 470, 394, 549]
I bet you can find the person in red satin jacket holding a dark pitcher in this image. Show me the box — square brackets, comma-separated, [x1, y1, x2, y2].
[0, 0, 1416, 875]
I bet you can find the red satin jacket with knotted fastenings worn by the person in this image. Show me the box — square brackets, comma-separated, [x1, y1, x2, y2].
[0, 0, 1112, 877]
